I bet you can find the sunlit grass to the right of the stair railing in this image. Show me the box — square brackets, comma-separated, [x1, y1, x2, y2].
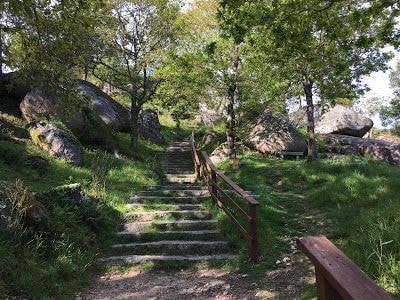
[212, 152, 400, 299]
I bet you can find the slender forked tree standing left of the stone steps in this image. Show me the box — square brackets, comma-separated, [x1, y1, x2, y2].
[93, 0, 179, 148]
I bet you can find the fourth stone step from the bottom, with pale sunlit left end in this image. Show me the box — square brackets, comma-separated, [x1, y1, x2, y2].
[122, 220, 217, 232]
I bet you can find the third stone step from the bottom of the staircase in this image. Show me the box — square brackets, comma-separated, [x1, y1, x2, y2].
[118, 230, 223, 242]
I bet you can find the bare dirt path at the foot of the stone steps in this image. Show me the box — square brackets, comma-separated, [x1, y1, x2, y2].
[75, 255, 312, 300]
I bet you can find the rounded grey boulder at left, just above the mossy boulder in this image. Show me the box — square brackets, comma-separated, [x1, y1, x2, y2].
[20, 88, 85, 135]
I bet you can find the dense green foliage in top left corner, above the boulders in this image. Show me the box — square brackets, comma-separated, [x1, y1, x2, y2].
[2, 0, 108, 87]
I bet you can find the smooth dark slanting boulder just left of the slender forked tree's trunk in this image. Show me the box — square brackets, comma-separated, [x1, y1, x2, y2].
[78, 80, 130, 132]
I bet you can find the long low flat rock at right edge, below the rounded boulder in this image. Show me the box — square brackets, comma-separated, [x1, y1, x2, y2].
[321, 134, 400, 165]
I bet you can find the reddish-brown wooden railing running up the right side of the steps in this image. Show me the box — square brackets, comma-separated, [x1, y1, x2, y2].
[191, 132, 258, 262]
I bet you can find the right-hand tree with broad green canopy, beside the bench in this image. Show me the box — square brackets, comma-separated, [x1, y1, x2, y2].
[220, 0, 399, 160]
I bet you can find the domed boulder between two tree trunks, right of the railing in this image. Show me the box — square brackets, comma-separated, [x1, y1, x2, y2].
[245, 109, 307, 154]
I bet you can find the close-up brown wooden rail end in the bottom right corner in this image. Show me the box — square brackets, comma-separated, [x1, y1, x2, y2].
[297, 236, 392, 300]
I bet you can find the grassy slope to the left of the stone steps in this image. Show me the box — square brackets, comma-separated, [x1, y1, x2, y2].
[0, 115, 187, 299]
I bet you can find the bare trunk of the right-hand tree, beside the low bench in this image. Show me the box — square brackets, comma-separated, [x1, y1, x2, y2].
[303, 78, 317, 161]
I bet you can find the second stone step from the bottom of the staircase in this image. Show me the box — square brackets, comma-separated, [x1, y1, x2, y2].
[111, 240, 231, 255]
